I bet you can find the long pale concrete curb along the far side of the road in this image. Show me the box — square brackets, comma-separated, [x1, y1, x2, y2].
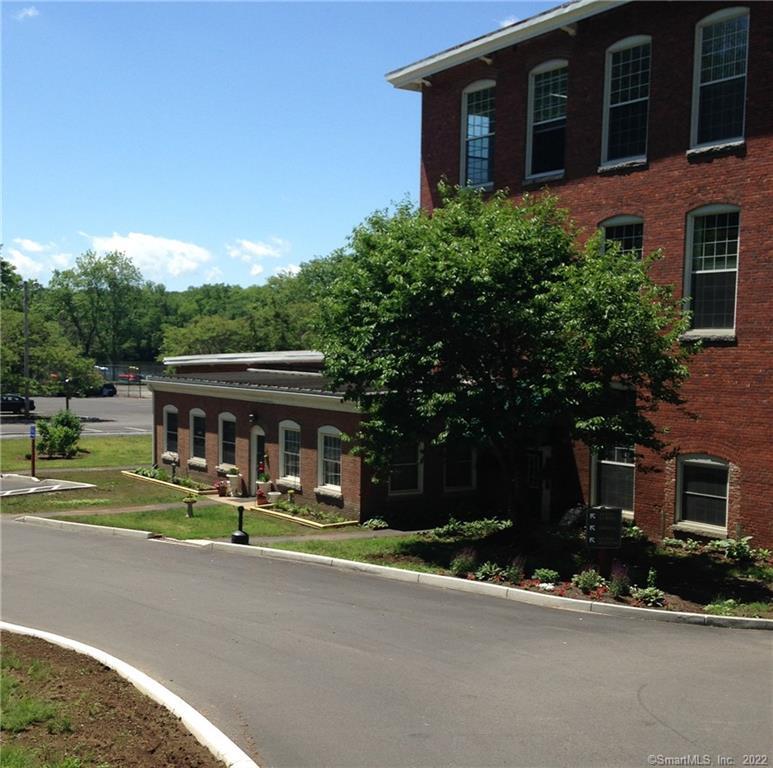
[16, 517, 773, 630]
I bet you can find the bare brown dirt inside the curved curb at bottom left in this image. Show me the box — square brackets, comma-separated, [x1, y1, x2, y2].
[0, 632, 224, 768]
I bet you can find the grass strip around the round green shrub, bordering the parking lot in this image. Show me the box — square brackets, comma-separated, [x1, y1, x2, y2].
[0, 435, 152, 472]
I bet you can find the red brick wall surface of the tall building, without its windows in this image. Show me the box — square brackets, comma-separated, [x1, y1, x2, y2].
[406, 2, 773, 547]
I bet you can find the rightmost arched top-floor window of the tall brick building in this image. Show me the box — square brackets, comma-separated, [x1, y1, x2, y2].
[690, 7, 749, 147]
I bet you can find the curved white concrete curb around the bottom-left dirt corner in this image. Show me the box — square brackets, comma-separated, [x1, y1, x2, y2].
[0, 616, 258, 768]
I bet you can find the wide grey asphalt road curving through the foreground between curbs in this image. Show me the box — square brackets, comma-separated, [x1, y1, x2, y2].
[2, 518, 773, 768]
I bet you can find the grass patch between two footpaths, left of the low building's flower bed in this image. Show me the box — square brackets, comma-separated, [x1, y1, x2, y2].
[0, 470, 187, 515]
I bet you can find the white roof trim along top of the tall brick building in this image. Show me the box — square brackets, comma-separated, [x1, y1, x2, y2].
[386, 0, 632, 91]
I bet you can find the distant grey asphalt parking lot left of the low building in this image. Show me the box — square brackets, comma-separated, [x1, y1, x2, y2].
[0, 396, 153, 437]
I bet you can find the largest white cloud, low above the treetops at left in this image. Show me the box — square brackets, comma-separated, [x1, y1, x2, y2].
[86, 232, 212, 280]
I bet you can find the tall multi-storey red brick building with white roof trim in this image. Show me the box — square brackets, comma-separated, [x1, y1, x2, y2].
[387, 0, 773, 547]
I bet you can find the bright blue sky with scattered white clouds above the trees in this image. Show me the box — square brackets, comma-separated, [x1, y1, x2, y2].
[0, 2, 557, 290]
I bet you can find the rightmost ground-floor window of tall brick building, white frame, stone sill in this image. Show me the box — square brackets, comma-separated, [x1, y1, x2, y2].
[676, 455, 730, 531]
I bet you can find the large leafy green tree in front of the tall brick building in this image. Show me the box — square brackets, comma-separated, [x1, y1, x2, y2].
[320, 187, 688, 515]
